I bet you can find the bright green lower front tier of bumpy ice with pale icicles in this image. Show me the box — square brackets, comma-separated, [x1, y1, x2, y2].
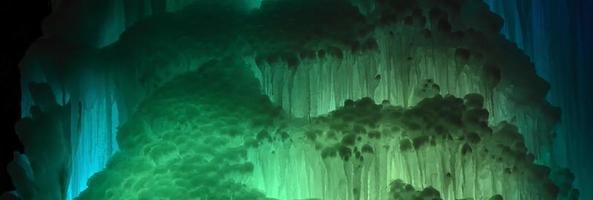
[79, 58, 575, 200]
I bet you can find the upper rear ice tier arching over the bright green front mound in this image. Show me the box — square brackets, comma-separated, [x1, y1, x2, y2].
[8, 0, 584, 197]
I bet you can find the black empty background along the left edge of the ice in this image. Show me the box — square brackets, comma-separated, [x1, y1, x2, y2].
[0, 0, 51, 191]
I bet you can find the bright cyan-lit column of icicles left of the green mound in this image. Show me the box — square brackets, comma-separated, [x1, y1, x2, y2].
[68, 77, 120, 199]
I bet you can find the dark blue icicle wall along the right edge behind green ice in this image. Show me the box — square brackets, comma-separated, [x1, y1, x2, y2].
[487, 0, 593, 199]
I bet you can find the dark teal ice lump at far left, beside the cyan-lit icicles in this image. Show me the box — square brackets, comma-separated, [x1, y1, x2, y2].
[8, 84, 72, 199]
